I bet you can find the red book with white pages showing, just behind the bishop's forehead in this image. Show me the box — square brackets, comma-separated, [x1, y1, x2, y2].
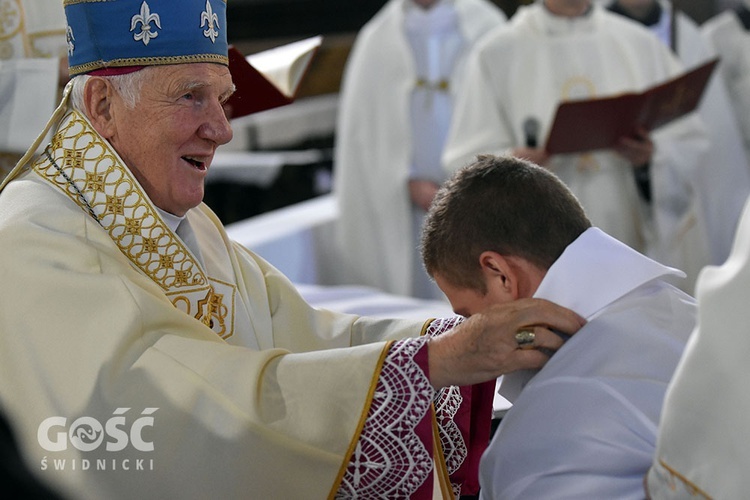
[227, 36, 323, 118]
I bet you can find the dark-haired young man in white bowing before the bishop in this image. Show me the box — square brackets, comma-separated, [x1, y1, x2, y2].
[422, 155, 696, 499]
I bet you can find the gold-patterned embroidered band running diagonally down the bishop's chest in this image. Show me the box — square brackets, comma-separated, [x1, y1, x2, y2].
[33, 111, 235, 338]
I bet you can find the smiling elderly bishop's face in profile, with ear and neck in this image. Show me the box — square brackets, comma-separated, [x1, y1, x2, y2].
[109, 63, 234, 216]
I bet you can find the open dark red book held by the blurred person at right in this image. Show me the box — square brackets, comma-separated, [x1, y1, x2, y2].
[545, 59, 719, 154]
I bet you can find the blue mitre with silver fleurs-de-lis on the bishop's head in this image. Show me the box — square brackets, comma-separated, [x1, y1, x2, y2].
[63, 0, 229, 76]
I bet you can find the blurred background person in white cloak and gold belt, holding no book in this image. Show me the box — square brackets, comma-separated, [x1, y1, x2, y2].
[334, 0, 505, 299]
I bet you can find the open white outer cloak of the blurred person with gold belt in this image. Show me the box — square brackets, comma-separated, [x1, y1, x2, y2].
[334, 0, 505, 295]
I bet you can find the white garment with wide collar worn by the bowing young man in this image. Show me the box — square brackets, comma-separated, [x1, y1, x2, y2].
[480, 228, 696, 500]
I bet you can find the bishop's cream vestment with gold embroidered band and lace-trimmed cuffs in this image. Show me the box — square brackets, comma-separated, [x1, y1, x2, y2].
[0, 94, 492, 499]
